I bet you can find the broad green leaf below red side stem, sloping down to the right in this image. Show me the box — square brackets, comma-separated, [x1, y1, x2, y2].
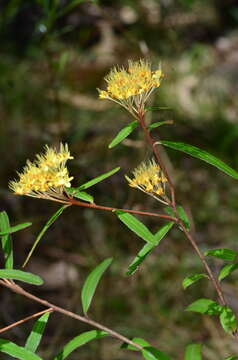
[115, 210, 156, 245]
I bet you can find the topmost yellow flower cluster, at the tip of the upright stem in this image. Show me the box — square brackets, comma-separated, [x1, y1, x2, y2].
[98, 60, 163, 118]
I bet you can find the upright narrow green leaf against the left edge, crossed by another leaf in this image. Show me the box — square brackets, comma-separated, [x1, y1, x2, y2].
[0, 211, 13, 269]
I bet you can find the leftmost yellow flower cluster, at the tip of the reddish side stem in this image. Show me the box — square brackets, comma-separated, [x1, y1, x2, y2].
[9, 144, 73, 201]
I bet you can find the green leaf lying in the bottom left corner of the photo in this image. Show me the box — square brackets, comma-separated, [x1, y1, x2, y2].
[0, 339, 43, 360]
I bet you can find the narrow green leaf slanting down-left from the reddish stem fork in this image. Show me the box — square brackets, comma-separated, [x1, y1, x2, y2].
[126, 222, 174, 275]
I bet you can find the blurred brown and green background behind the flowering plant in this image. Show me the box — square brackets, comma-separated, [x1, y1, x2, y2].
[0, 0, 238, 360]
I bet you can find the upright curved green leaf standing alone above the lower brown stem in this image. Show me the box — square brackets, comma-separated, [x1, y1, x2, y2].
[81, 258, 113, 314]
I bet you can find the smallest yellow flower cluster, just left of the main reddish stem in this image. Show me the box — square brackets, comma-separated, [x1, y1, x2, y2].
[126, 160, 167, 201]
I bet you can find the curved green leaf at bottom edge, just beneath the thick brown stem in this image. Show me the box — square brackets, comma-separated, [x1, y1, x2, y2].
[54, 330, 108, 360]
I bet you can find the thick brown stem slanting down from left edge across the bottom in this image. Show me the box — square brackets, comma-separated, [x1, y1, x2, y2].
[0, 280, 142, 350]
